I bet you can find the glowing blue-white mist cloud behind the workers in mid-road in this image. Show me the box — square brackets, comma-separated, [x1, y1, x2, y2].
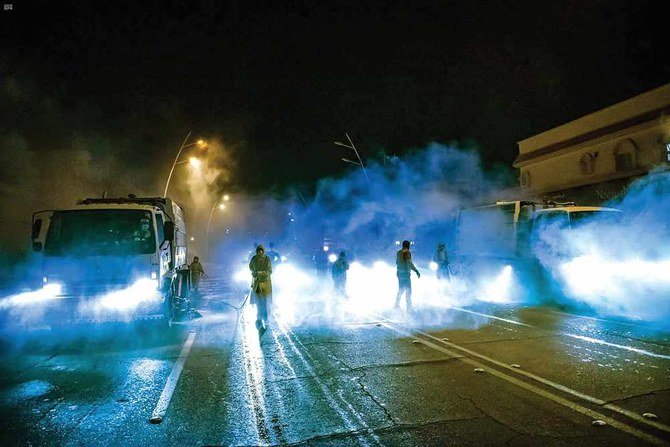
[228, 144, 514, 323]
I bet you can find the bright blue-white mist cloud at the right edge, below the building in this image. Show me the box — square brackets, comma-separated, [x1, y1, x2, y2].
[534, 172, 670, 323]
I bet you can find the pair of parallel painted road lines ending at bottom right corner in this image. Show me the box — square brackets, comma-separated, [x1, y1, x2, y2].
[381, 318, 667, 445]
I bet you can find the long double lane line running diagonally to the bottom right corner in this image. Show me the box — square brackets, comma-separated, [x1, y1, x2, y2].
[381, 319, 668, 446]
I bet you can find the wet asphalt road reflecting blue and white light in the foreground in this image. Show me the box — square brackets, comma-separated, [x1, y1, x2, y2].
[0, 274, 670, 446]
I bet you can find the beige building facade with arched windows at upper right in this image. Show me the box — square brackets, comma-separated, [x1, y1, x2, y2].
[514, 84, 670, 205]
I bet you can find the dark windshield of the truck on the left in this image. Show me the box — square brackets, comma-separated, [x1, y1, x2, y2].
[44, 210, 156, 256]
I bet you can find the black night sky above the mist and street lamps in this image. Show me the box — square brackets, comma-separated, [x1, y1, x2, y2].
[0, 0, 670, 192]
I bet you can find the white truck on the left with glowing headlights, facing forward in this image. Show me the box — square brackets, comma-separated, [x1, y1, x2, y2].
[32, 195, 189, 324]
